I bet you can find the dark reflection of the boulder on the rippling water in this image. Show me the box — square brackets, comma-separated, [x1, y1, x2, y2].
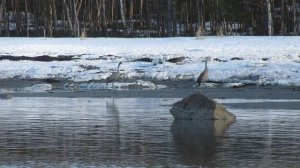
[171, 120, 230, 167]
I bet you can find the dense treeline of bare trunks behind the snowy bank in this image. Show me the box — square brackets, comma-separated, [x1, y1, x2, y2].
[0, 0, 300, 37]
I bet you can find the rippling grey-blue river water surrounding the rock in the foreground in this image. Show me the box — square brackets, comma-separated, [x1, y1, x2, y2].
[0, 97, 300, 168]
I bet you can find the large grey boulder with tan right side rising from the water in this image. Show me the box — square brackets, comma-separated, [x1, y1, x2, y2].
[170, 93, 236, 122]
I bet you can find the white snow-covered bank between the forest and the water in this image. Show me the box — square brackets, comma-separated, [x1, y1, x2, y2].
[0, 36, 300, 86]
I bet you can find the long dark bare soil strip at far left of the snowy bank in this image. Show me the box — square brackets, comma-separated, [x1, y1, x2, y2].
[0, 55, 78, 62]
